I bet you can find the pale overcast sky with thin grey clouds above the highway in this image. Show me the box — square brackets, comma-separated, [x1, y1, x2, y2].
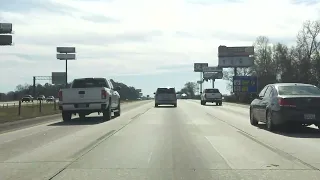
[0, 0, 320, 94]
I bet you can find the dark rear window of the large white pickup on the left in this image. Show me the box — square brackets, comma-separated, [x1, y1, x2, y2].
[72, 78, 109, 88]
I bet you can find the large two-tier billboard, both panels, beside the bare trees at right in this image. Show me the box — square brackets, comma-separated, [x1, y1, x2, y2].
[218, 46, 254, 68]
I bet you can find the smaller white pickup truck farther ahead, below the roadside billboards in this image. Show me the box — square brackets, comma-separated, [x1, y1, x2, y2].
[200, 88, 222, 106]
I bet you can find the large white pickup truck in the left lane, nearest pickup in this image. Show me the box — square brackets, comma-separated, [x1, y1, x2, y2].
[58, 78, 121, 121]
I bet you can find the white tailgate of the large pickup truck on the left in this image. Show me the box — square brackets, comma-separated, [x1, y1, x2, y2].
[62, 88, 102, 103]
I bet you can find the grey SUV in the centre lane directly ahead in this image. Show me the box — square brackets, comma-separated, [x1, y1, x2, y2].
[154, 87, 177, 107]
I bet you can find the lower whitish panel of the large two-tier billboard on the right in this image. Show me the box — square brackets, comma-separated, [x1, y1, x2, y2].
[219, 56, 254, 68]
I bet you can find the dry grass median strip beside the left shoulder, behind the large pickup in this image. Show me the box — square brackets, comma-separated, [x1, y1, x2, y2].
[0, 100, 141, 123]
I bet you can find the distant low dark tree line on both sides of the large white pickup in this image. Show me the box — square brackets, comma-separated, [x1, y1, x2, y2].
[0, 79, 139, 101]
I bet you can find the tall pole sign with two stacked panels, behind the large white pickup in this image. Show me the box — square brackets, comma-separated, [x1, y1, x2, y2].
[57, 47, 76, 87]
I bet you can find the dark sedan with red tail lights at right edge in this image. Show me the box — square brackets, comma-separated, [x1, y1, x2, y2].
[250, 83, 320, 131]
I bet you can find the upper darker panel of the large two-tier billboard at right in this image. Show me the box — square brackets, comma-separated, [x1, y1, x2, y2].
[218, 46, 254, 57]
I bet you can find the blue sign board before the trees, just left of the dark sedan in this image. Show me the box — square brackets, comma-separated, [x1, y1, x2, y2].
[233, 76, 258, 93]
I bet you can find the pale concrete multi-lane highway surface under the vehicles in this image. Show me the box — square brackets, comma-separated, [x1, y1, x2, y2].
[0, 100, 320, 180]
